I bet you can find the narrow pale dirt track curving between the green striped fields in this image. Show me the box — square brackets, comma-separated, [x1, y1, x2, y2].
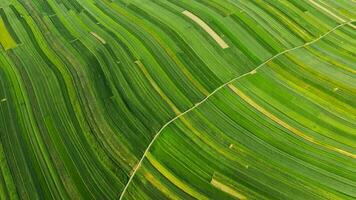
[119, 20, 354, 200]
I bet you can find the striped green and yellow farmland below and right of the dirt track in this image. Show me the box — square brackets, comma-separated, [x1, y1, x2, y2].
[123, 23, 356, 199]
